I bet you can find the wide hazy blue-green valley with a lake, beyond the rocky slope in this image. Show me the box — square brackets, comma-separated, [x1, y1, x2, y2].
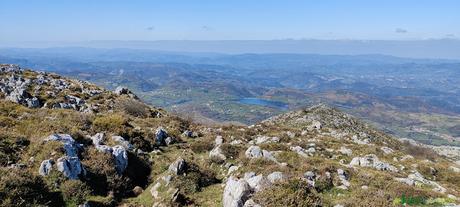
[0, 48, 460, 146]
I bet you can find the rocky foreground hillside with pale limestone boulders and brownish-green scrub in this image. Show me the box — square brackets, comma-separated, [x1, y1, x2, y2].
[0, 65, 460, 207]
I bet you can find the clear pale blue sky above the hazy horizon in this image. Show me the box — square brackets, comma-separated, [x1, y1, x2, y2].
[0, 0, 460, 42]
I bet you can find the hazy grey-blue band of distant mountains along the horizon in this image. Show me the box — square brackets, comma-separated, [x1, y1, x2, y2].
[0, 39, 460, 60]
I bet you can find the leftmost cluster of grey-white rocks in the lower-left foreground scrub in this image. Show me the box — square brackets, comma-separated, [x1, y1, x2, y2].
[38, 134, 86, 179]
